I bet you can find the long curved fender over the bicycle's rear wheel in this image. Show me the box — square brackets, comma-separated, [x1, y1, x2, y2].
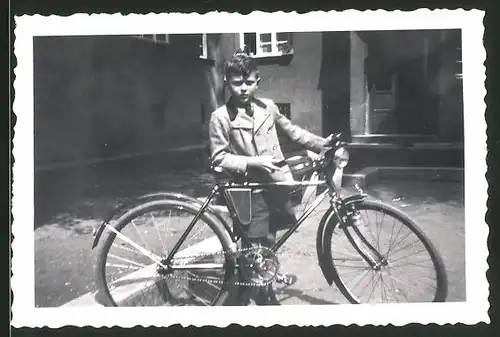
[92, 192, 232, 249]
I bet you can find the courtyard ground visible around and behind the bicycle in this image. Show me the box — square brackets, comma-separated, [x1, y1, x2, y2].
[35, 161, 465, 307]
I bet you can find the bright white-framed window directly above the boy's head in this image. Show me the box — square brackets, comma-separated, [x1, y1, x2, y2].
[240, 32, 293, 57]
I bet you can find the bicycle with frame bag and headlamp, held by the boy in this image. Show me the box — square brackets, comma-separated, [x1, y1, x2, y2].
[92, 133, 448, 306]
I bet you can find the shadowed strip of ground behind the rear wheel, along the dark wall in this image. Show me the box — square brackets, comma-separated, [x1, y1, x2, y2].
[35, 156, 213, 233]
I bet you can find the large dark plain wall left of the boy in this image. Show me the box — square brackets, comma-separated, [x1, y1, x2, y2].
[34, 36, 215, 167]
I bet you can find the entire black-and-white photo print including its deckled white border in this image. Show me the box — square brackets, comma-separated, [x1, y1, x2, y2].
[13, 11, 488, 326]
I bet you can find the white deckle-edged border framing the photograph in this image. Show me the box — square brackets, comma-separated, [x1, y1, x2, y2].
[12, 9, 490, 328]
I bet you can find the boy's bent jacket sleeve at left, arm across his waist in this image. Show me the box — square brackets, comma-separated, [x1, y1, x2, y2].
[208, 114, 249, 174]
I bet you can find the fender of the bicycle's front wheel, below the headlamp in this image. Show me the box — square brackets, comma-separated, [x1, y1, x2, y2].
[316, 195, 365, 286]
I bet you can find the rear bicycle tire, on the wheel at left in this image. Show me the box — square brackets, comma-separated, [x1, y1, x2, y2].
[96, 199, 234, 306]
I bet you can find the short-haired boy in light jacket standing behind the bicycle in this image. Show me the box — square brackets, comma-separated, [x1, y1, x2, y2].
[209, 52, 329, 304]
